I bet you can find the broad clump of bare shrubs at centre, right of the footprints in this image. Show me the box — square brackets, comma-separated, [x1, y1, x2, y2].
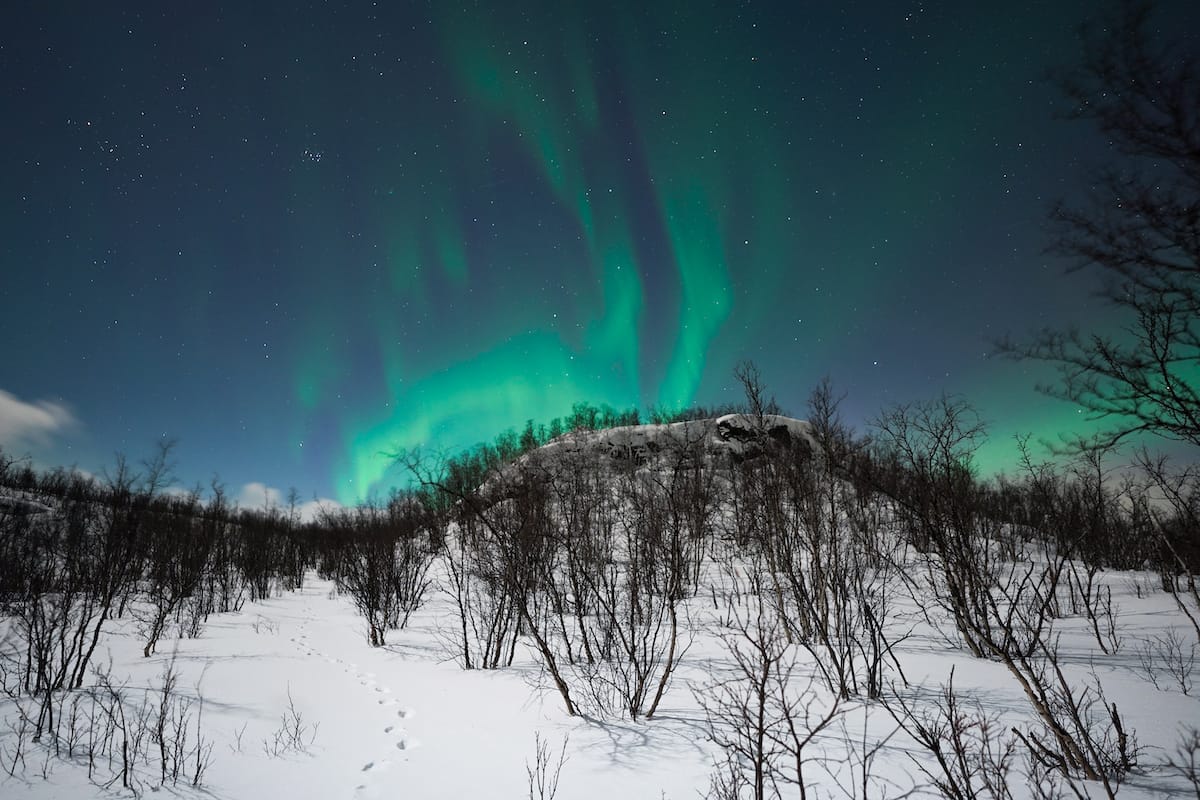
[407, 443, 709, 718]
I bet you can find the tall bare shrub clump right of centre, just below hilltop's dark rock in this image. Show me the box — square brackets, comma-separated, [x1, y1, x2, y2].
[731, 381, 899, 698]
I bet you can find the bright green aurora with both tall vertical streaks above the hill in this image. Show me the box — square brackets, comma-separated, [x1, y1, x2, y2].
[302, 1, 840, 500]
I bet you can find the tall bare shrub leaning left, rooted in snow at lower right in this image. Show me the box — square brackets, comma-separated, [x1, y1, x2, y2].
[877, 398, 1138, 796]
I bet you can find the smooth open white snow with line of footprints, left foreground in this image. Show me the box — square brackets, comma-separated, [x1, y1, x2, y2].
[0, 568, 708, 799]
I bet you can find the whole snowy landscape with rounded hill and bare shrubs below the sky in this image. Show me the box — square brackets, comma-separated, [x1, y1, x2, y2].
[0, 434, 1200, 800]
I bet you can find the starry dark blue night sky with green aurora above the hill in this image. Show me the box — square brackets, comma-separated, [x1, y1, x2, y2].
[0, 0, 1194, 501]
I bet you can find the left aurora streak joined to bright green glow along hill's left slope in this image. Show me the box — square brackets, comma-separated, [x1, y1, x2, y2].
[314, 7, 667, 501]
